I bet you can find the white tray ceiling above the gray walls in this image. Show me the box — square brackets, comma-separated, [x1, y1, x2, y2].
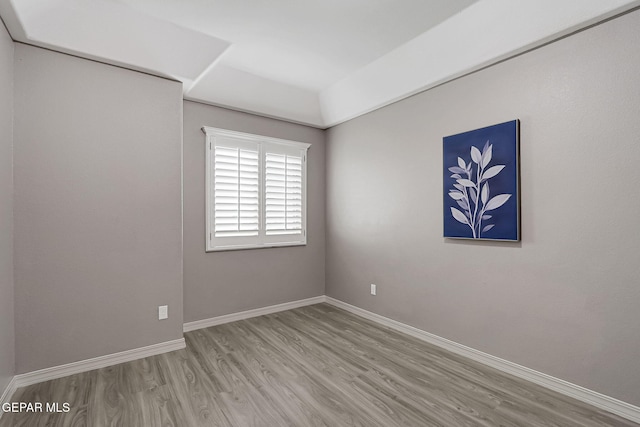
[0, 0, 640, 128]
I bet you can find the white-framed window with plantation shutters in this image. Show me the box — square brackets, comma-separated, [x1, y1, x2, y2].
[202, 127, 310, 251]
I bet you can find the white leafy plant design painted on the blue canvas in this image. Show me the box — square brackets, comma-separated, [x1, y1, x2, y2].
[449, 141, 512, 239]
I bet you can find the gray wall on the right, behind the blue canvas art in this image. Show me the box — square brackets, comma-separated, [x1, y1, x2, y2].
[327, 11, 640, 405]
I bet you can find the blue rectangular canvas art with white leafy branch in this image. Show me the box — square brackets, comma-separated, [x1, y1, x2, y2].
[442, 120, 520, 241]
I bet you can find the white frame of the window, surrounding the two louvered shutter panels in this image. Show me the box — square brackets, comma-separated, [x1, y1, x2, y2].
[202, 126, 311, 252]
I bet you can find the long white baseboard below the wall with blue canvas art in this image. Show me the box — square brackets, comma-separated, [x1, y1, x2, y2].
[326, 297, 640, 423]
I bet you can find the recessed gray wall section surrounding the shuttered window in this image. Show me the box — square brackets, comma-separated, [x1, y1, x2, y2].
[184, 101, 325, 322]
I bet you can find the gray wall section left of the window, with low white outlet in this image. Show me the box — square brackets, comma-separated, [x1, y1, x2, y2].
[14, 44, 183, 373]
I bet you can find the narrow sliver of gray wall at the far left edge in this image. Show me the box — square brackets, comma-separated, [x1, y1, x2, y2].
[0, 22, 14, 395]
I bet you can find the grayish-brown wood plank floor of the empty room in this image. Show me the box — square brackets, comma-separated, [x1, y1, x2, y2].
[0, 304, 637, 427]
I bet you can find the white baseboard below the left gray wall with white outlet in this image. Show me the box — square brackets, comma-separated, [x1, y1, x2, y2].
[14, 338, 186, 388]
